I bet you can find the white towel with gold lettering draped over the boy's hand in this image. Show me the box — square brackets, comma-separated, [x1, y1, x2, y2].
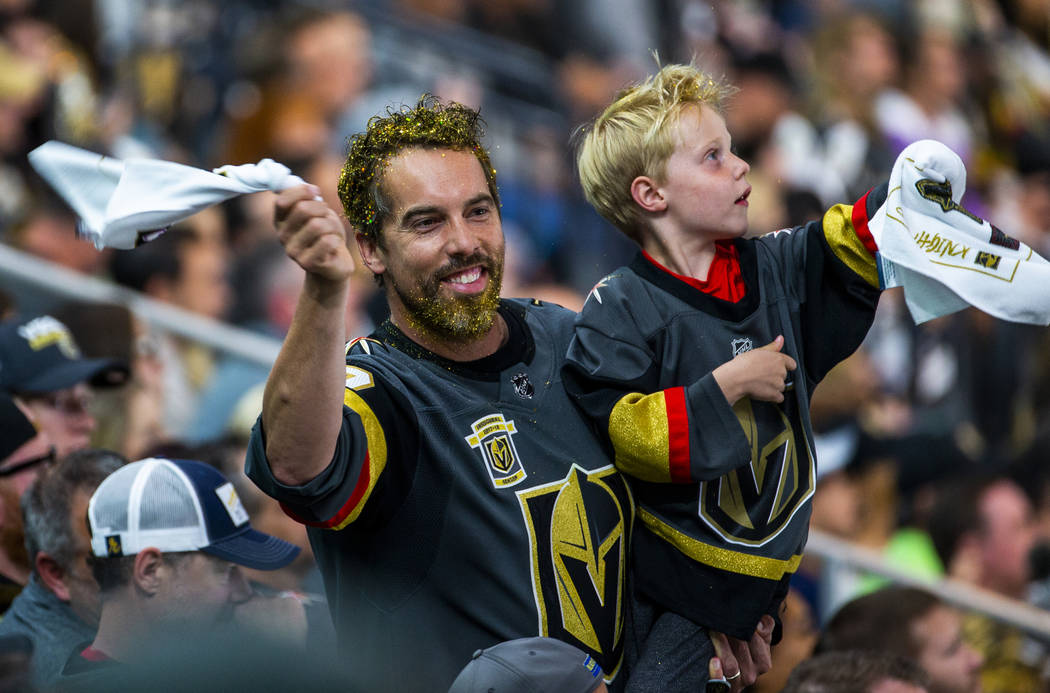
[868, 140, 1050, 324]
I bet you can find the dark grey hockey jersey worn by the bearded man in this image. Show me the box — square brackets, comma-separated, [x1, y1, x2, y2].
[248, 299, 634, 692]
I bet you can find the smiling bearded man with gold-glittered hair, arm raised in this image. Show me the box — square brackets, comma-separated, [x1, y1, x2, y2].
[247, 99, 633, 691]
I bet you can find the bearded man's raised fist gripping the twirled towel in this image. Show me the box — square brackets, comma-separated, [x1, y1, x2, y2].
[274, 185, 354, 282]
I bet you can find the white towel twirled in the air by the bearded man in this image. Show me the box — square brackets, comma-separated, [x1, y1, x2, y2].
[29, 141, 302, 250]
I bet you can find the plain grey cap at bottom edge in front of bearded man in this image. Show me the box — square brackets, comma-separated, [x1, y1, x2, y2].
[448, 637, 602, 693]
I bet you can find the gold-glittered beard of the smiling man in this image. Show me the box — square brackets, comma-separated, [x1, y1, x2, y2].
[391, 253, 503, 342]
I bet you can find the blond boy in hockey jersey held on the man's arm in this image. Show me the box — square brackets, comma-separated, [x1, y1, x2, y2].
[564, 65, 885, 690]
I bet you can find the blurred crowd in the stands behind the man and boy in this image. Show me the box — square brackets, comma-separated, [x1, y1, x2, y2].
[0, 0, 1050, 692]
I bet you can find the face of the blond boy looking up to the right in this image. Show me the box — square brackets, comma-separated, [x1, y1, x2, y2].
[658, 106, 751, 240]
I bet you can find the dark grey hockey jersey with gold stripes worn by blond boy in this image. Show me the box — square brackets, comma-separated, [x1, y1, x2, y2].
[565, 187, 885, 639]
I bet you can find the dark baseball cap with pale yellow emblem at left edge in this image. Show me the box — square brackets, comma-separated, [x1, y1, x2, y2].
[0, 315, 128, 393]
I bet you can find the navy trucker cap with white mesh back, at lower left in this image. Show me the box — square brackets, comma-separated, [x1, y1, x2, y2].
[87, 458, 299, 570]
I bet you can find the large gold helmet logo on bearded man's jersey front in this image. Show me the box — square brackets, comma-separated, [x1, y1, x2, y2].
[518, 465, 634, 680]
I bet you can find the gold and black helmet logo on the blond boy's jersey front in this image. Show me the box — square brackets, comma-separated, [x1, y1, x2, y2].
[699, 396, 816, 546]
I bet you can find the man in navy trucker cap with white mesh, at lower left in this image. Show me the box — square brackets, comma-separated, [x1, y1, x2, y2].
[63, 458, 298, 676]
